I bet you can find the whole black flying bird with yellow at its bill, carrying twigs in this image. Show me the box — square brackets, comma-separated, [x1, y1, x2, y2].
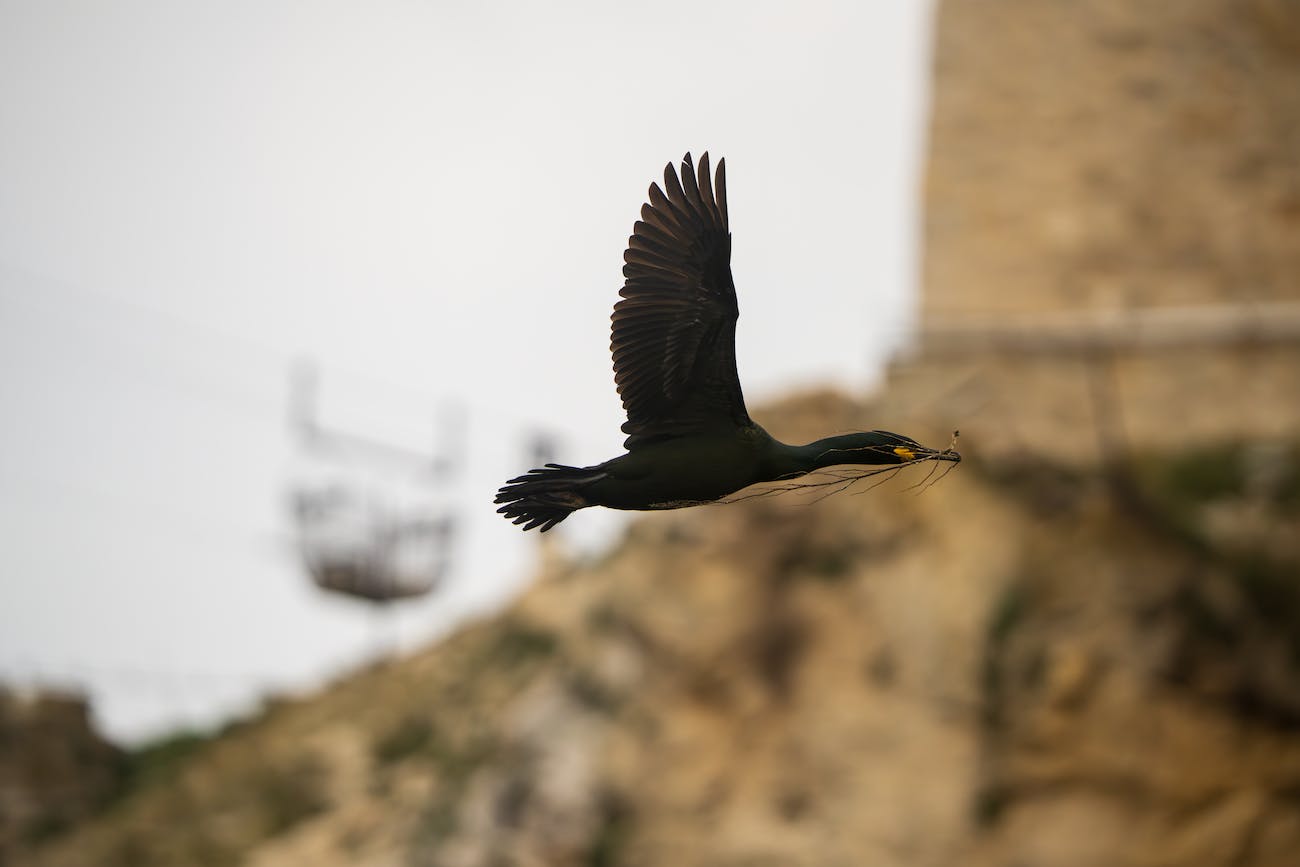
[497, 153, 961, 533]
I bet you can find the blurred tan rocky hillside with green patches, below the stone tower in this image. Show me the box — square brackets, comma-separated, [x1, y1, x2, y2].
[16, 395, 1300, 867]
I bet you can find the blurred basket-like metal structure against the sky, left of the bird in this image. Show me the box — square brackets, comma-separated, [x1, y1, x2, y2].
[290, 364, 462, 604]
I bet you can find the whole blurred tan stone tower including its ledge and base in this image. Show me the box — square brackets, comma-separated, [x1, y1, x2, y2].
[885, 0, 1300, 460]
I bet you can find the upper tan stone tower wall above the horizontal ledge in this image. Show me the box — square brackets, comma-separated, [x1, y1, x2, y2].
[924, 0, 1300, 320]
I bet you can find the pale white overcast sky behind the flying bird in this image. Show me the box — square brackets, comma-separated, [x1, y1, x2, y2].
[0, 0, 931, 738]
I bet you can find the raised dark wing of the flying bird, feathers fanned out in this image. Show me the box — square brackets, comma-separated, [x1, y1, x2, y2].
[610, 153, 749, 448]
